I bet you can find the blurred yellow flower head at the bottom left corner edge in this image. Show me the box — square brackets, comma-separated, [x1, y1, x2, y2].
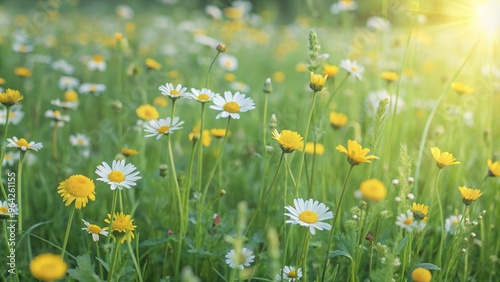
[30, 253, 68, 282]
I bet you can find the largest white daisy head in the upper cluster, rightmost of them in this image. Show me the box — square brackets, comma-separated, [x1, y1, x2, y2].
[210, 91, 255, 119]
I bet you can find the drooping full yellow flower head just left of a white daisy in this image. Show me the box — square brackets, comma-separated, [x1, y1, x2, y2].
[57, 174, 95, 209]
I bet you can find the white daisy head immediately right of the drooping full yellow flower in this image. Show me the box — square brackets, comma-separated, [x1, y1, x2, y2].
[95, 160, 141, 190]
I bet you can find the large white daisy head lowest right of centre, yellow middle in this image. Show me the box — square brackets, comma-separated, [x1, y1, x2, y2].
[285, 198, 333, 235]
